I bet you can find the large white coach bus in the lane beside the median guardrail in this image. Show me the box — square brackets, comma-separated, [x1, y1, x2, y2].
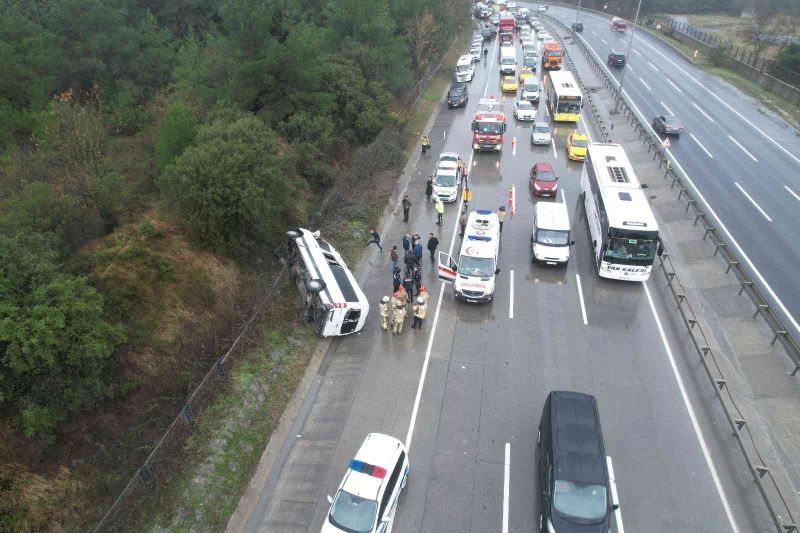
[581, 143, 661, 281]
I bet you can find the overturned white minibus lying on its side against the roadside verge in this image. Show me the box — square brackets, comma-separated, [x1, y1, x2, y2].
[286, 228, 369, 337]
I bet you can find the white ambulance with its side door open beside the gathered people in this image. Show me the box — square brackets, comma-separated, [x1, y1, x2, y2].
[438, 209, 500, 303]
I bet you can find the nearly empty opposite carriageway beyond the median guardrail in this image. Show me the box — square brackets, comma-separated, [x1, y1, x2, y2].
[548, 7, 800, 332]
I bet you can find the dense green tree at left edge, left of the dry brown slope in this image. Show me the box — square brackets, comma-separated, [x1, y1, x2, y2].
[0, 233, 125, 439]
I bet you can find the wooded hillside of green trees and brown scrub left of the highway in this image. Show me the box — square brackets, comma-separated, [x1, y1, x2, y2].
[0, 0, 469, 530]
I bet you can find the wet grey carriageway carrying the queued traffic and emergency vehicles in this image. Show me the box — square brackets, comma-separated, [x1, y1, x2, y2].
[239, 25, 776, 532]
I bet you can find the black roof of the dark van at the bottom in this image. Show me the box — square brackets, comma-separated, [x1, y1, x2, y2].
[550, 391, 606, 485]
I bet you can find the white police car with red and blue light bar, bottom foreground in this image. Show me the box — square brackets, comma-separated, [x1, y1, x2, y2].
[321, 433, 409, 533]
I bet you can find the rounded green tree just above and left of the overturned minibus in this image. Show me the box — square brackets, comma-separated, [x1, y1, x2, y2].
[159, 115, 291, 254]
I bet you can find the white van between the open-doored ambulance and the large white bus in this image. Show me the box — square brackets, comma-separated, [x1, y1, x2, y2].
[531, 202, 575, 266]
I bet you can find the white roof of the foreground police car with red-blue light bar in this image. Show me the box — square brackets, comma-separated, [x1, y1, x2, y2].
[342, 433, 405, 500]
